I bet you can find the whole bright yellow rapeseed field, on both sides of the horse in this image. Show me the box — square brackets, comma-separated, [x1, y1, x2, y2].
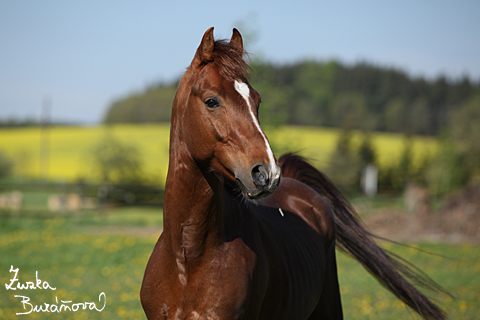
[0, 124, 438, 184]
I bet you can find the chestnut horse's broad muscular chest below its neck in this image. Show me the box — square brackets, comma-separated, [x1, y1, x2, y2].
[147, 243, 254, 320]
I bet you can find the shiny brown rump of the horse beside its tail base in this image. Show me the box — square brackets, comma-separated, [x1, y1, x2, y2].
[259, 178, 335, 240]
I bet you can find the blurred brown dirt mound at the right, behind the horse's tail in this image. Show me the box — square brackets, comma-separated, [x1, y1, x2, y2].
[365, 185, 480, 244]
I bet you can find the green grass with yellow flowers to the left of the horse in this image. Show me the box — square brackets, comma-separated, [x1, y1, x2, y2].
[0, 218, 155, 319]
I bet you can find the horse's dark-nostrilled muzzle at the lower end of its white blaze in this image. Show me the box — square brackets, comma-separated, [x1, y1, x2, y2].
[235, 162, 280, 200]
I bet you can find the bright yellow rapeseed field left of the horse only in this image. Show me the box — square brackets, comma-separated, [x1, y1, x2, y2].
[0, 125, 169, 185]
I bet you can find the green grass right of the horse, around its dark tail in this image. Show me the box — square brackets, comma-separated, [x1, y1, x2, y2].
[337, 243, 480, 320]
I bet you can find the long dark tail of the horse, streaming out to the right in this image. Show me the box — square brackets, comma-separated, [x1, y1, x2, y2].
[279, 154, 448, 319]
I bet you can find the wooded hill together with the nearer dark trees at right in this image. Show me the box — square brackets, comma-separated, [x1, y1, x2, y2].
[104, 61, 480, 196]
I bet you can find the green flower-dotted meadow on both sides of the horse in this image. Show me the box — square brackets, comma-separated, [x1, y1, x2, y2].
[0, 208, 480, 320]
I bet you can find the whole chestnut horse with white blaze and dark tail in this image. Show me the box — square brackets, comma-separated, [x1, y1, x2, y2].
[141, 28, 445, 320]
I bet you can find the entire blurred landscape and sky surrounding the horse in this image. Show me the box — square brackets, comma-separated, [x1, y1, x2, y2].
[0, 1, 480, 319]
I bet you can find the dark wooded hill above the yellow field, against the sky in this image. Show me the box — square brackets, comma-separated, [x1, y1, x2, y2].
[103, 61, 480, 135]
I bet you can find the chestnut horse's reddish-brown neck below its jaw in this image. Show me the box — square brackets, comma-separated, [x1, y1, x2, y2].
[163, 106, 223, 259]
